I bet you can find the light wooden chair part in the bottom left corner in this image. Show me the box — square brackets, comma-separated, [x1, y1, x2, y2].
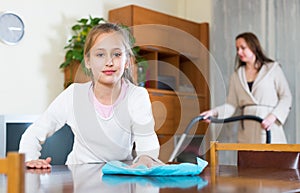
[0, 152, 25, 193]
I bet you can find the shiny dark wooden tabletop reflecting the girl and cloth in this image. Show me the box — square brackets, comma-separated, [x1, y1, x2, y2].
[0, 164, 300, 193]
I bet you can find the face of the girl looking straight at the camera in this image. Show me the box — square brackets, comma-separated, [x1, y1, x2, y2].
[86, 32, 128, 85]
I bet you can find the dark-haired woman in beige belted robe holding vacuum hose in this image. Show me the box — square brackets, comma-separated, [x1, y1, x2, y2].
[200, 32, 292, 143]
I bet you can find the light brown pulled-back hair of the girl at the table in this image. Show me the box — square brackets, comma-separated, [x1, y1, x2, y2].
[83, 22, 135, 83]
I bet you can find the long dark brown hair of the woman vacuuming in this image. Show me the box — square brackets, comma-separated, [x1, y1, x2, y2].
[235, 32, 274, 71]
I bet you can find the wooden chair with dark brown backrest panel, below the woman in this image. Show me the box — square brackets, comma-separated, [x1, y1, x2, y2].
[210, 141, 300, 169]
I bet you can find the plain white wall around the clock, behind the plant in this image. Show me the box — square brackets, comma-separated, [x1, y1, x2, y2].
[0, 0, 211, 114]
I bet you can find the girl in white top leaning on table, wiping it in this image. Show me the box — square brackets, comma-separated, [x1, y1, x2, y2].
[19, 23, 161, 168]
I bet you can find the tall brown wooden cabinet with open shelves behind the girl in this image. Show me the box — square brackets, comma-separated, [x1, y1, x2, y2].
[109, 5, 210, 160]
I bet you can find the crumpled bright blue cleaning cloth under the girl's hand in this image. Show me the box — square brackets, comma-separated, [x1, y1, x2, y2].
[102, 157, 208, 176]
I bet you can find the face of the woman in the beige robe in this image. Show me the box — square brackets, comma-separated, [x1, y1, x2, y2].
[236, 38, 256, 63]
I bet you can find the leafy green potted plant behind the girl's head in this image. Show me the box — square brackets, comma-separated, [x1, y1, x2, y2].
[59, 16, 148, 88]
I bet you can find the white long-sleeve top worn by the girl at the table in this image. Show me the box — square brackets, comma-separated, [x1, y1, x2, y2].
[19, 82, 159, 164]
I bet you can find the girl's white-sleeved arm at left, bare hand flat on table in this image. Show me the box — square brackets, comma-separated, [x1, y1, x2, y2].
[19, 86, 72, 168]
